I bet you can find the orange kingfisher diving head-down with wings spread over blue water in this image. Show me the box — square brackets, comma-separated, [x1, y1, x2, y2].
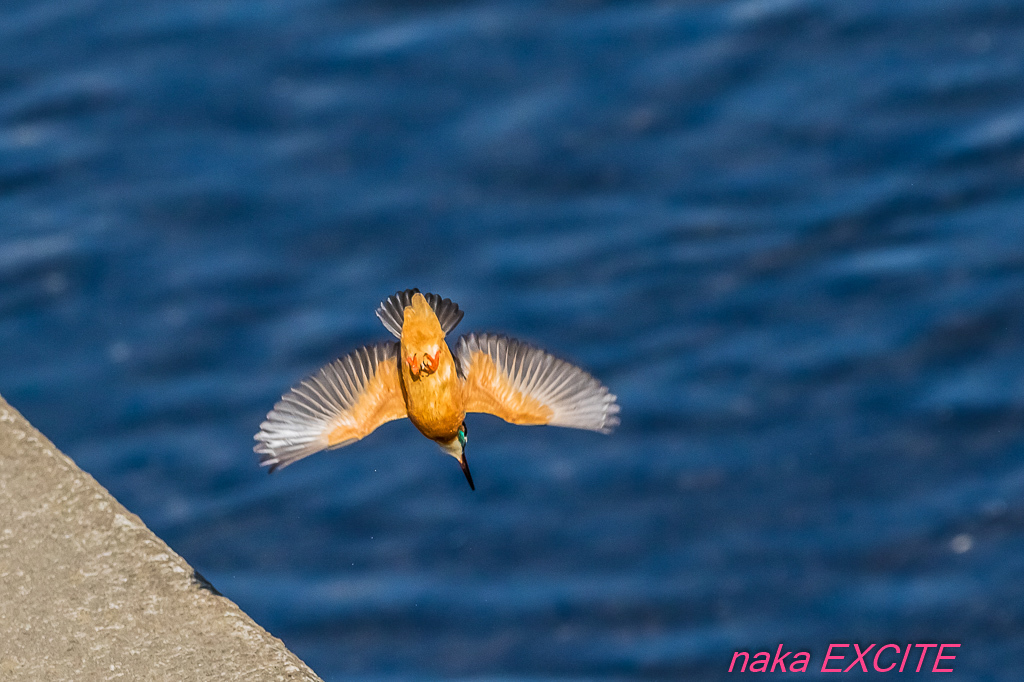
[260, 289, 618, 491]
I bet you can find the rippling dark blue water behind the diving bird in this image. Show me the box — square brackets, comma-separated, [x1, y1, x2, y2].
[0, 0, 1024, 680]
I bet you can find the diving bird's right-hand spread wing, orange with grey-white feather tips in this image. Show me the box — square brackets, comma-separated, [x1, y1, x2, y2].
[456, 334, 618, 433]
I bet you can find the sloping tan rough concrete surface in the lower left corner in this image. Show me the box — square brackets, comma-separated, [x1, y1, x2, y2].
[0, 398, 319, 682]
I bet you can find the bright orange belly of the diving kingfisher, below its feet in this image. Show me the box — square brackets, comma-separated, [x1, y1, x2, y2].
[401, 345, 466, 442]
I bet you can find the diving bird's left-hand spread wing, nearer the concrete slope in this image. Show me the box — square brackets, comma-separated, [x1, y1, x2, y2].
[253, 343, 408, 471]
